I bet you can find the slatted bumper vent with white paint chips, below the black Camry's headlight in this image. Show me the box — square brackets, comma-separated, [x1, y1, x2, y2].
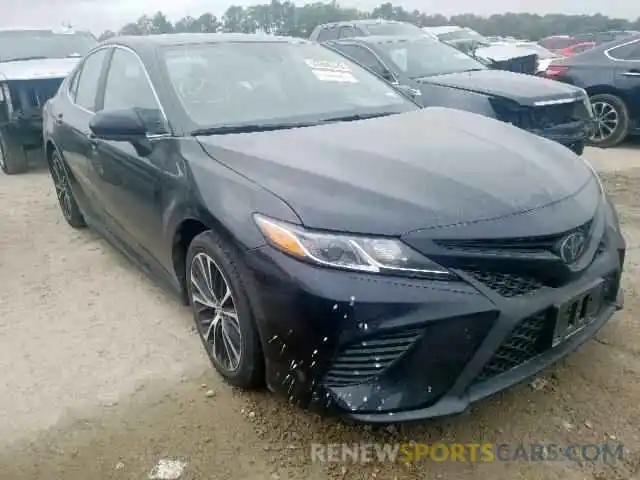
[322, 330, 422, 387]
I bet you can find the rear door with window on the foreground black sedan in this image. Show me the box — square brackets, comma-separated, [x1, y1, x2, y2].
[51, 48, 110, 220]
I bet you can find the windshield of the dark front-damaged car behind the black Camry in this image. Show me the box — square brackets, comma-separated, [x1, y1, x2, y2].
[378, 39, 487, 78]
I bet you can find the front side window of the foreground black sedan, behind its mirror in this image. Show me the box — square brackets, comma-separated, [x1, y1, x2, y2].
[103, 48, 167, 134]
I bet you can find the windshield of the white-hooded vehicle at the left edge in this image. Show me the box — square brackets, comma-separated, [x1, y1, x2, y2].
[0, 30, 98, 62]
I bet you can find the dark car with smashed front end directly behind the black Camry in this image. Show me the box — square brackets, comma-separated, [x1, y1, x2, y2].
[324, 36, 592, 155]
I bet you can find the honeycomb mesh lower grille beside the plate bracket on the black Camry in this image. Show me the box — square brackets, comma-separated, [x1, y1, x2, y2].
[475, 310, 553, 383]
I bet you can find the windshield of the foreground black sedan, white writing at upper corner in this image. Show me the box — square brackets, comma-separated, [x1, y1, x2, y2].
[164, 42, 418, 130]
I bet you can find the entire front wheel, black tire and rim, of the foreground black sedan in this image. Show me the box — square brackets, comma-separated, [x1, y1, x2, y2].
[186, 231, 265, 389]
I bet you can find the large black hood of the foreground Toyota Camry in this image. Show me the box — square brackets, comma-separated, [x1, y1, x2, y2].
[198, 107, 597, 235]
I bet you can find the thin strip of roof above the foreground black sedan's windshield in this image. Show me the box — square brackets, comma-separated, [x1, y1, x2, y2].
[102, 33, 311, 50]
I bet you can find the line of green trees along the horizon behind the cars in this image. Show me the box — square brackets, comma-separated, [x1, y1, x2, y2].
[100, 0, 640, 40]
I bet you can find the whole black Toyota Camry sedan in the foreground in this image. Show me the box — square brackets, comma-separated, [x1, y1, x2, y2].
[44, 34, 625, 422]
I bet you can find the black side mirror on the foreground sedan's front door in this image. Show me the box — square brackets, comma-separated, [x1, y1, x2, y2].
[89, 108, 147, 142]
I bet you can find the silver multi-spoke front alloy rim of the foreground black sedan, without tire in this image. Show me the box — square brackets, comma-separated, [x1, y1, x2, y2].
[190, 252, 243, 372]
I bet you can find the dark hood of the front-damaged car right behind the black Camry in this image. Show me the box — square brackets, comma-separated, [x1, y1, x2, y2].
[416, 69, 583, 105]
